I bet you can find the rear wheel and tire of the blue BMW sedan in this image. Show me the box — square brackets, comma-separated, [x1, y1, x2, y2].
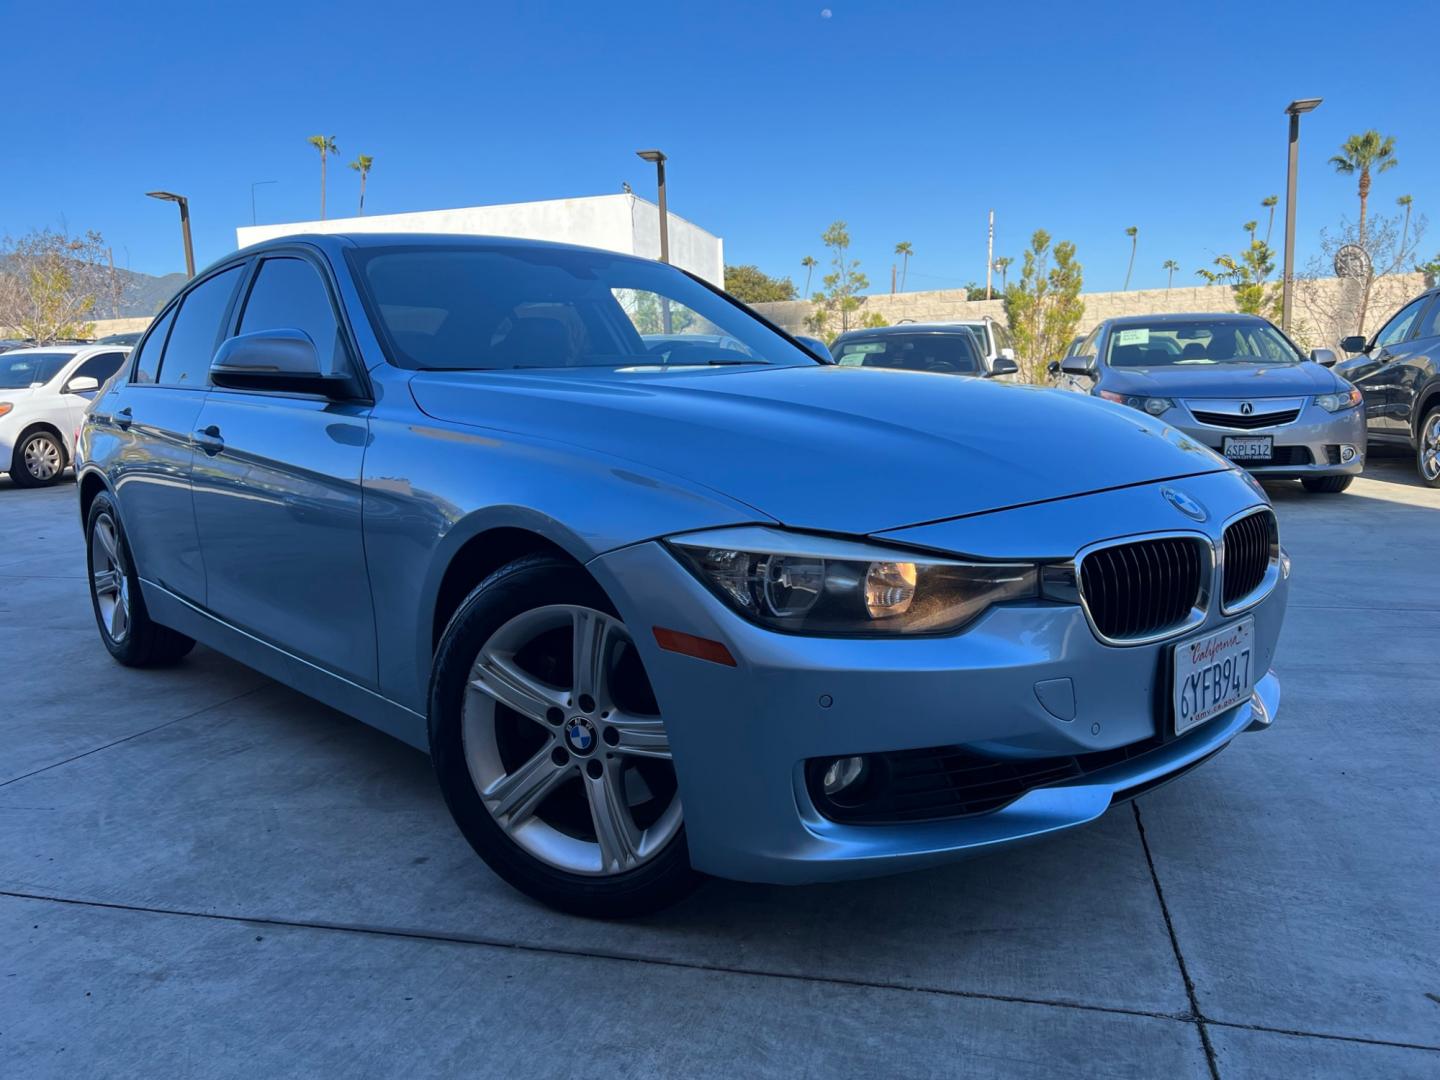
[85, 494, 194, 668]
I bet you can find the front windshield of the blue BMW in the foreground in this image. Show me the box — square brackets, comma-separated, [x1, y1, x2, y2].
[350, 245, 816, 370]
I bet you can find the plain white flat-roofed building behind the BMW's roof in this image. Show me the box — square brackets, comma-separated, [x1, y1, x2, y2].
[243, 194, 724, 287]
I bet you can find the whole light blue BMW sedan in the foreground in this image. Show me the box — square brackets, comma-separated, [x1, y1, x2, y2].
[78, 235, 1289, 916]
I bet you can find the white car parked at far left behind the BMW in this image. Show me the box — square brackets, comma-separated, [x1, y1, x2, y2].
[0, 346, 130, 488]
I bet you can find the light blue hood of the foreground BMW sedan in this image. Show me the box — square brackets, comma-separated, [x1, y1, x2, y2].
[410, 366, 1228, 534]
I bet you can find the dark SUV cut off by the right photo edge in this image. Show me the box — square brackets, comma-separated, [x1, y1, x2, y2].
[1335, 288, 1440, 488]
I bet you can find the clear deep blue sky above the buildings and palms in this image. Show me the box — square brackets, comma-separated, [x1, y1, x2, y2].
[0, 0, 1440, 291]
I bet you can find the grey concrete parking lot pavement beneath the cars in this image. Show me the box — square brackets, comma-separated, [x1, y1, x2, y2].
[0, 459, 1440, 1077]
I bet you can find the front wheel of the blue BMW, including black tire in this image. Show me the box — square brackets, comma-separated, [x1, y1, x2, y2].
[429, 556, 700, 919]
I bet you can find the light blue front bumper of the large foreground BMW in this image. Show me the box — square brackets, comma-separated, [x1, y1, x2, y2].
[590, 474, 1289, 884]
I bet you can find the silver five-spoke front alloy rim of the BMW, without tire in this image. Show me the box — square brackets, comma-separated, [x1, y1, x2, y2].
[461, 605, 681, 877]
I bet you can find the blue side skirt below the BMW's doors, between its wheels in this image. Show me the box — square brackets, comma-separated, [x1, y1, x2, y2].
[140, 579, 429, 753]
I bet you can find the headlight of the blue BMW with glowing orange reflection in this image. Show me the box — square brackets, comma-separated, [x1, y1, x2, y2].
[668, 527, 1040, 634]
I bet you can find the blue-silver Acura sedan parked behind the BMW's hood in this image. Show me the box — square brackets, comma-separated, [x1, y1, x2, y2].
[1053, 314, 1365, 494]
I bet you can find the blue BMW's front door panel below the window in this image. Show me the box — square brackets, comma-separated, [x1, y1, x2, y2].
[192, 390, 377, 687]
